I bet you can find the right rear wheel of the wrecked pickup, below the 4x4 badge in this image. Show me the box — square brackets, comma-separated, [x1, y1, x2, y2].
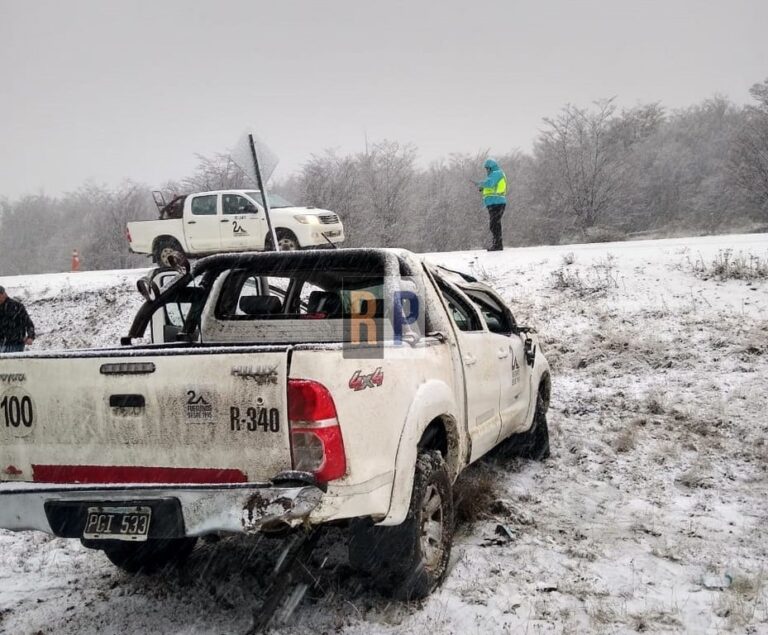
[349, 451, 455, 600]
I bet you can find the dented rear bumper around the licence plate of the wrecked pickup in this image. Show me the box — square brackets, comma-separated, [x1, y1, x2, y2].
[0, 483, 323, 537]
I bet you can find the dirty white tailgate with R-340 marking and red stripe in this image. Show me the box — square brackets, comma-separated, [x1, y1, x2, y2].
[0, 348, 291, 483]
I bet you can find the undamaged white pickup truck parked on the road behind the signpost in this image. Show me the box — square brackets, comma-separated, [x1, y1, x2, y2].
[126, 190, 344, 265]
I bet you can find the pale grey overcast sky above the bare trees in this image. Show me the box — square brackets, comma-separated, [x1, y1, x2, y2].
[0, 0, 768, 197]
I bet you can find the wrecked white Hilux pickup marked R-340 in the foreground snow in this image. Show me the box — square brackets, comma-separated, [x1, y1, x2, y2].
[0, 249, 550, 598]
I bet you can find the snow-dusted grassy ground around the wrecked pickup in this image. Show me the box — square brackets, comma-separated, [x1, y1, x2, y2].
[0, 235, 768, 635]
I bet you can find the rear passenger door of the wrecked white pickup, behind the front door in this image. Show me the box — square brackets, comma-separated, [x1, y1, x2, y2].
[438, 279, 501, 461]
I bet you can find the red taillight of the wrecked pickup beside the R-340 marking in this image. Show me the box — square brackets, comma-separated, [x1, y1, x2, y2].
[288, 379, 347, 483]
